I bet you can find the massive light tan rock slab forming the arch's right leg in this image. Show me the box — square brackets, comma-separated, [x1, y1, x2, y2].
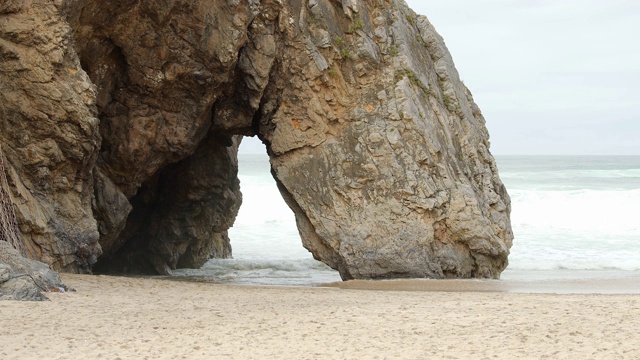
[260, 0, 512, 279]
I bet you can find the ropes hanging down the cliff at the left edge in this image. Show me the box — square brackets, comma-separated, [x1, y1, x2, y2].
[0, 146, 25, 255]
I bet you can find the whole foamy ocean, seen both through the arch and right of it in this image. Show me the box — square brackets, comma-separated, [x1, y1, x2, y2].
[173, 150, 640, 286]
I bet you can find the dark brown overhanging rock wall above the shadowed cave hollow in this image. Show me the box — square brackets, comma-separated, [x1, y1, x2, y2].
[65, 0, 252, 198]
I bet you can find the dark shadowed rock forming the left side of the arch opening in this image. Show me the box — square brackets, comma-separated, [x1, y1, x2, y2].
[97, 137, 242, 274]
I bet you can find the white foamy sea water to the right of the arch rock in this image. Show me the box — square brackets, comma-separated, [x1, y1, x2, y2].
[496, 156, 640, 279]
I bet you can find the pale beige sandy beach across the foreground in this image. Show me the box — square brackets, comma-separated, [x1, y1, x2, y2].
[0, 275, 640, 359]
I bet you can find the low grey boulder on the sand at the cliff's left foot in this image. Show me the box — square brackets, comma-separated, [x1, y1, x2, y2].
[0, 241, 68, 301]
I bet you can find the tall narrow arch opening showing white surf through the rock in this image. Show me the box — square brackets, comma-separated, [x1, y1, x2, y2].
[172, 137, 340, 285]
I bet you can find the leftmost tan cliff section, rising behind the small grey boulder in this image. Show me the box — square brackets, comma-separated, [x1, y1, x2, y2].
[0, 1, 100, 271]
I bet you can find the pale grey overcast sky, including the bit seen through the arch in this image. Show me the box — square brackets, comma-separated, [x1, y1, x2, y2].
[243, 0, 640, 155]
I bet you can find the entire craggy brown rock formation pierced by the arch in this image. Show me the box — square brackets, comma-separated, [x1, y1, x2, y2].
[0, 0, 513, 279]
